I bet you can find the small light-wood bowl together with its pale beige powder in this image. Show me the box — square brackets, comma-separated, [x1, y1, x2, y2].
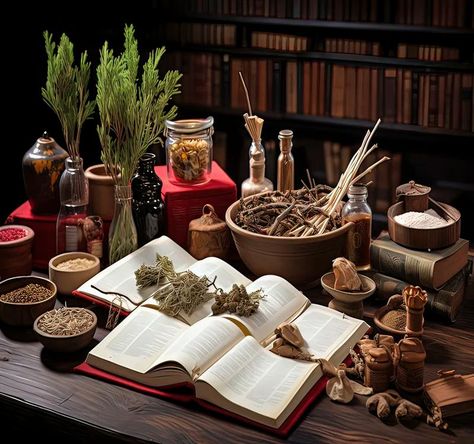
[49, 251, 100, 295]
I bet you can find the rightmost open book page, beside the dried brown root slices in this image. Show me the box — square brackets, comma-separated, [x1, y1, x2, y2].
[293, 304, 369, 366]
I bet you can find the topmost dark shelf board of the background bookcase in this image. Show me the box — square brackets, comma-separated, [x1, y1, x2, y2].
[179, 14, 474, 38]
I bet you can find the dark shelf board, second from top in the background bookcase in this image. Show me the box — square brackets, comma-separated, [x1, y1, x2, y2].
[168, 44, 474, 72]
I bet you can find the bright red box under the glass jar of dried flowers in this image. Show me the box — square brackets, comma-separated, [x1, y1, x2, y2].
[155, 162, 237, 248]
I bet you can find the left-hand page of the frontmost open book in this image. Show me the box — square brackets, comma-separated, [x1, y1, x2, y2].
[86, 307, 189, 373]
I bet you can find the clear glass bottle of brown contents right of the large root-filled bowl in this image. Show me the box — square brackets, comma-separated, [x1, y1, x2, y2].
[342, 184, 372, 270]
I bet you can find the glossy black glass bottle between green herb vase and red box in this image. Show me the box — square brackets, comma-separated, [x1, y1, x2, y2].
[132, 153, 165, 247]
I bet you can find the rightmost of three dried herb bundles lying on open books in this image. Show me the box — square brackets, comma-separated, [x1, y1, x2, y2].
[211, 284, 264, 317]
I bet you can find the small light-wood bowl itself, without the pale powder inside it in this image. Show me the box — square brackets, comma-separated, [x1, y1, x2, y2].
[49, 251, 100, 295]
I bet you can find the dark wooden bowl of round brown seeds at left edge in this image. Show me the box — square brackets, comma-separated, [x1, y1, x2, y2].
[0, 276, 57, 326]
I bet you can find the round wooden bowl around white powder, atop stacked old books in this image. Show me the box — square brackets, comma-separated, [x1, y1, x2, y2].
[387, 202, 461, 250]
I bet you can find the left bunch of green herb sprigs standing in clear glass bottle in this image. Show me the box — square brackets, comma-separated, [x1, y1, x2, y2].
[41, 31, 95, 159]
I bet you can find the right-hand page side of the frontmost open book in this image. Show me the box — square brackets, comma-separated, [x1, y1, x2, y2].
[196, 336, 322, 419]
